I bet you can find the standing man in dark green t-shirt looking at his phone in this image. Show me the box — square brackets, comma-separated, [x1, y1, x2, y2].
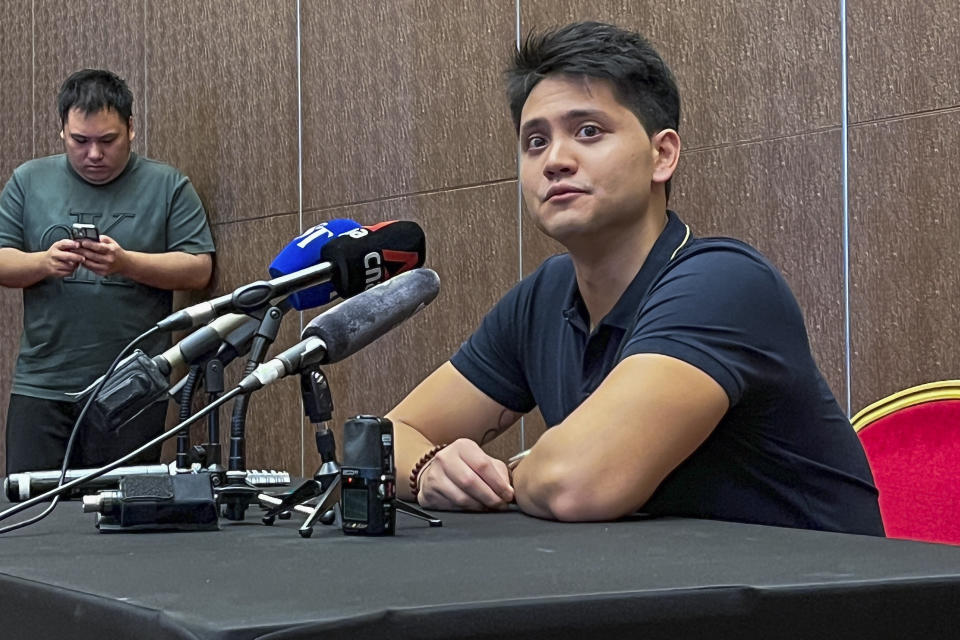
[0, 69, 214, 474]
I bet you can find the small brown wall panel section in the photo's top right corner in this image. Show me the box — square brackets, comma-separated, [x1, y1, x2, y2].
[847, 0, 960, 122]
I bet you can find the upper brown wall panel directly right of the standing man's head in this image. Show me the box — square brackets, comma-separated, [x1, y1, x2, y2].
[147, 0, 298, 226]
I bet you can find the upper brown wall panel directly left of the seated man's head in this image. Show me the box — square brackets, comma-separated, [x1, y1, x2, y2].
[301, 0, 515, 209]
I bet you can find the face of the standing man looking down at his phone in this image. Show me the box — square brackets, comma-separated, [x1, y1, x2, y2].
[60, 109, 134, 184]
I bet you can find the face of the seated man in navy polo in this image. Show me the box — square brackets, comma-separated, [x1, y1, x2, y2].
[520, 75, 657, 248]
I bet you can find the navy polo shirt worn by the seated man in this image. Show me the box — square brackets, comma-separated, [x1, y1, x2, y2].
[451, 212, 883, 535]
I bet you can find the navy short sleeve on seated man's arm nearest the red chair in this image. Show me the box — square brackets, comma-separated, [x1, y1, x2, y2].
[623, 241, 809, 406]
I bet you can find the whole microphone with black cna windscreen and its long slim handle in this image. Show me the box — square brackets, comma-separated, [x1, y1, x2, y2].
[156, 220, 426, 331]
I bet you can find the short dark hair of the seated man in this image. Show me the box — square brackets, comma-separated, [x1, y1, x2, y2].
[507, 22, 680, 197]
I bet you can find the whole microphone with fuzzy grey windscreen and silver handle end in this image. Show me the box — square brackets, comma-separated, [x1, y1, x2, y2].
[238, 269, 440, 393]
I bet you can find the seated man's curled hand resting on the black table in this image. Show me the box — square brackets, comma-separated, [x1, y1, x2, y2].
[416, 438, 513, 511]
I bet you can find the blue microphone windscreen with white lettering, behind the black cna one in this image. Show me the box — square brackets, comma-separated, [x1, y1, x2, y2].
[270, 218, 360, 311]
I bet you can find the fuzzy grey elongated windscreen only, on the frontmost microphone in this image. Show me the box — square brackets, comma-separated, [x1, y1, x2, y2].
[301, 269, 440, 364]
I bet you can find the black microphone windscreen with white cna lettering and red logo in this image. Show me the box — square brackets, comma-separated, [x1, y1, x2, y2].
[320, 220, 427, 298]
